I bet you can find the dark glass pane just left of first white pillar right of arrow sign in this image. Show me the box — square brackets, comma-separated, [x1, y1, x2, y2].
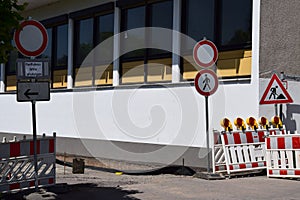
[55, 24, 68, 67]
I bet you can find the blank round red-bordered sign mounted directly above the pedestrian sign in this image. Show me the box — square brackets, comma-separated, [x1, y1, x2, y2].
[193, 40, 218, 67]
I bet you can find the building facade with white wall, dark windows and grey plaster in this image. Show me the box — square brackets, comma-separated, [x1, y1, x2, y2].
[0, 0, 300, 167]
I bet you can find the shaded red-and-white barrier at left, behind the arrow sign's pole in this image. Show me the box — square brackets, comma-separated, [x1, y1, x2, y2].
[0, 133, 56, 193]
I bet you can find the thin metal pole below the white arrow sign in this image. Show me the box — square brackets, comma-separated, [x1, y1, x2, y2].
[31, 100, 39, 190]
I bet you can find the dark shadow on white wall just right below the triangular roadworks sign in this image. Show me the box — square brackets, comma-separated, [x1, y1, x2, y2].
[283, 104, 300, 133]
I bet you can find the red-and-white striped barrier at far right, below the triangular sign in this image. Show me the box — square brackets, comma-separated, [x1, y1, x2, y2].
[266, 134, 300, 178]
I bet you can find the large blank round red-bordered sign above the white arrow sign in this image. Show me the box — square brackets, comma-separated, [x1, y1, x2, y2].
[14, 20, 48, 57]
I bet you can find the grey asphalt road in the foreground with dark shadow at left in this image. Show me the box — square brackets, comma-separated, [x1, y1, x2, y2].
[2, 165, 300, 200]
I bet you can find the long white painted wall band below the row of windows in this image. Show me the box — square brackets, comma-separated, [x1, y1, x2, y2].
[0, 81, 258, 147]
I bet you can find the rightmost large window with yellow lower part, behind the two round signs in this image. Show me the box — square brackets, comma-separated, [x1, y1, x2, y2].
[181, 0, 252, 80]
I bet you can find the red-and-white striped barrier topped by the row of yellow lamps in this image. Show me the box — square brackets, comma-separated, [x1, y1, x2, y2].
[213, 130, 266, 175]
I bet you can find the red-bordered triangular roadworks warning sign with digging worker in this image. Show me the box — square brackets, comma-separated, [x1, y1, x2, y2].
[259, 74, 293, 104]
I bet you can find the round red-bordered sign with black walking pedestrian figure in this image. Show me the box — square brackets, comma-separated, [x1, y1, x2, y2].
[195, 69, 219, 96]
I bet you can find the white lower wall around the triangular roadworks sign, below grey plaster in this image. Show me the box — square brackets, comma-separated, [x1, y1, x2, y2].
[259, 79, 300, 132]
